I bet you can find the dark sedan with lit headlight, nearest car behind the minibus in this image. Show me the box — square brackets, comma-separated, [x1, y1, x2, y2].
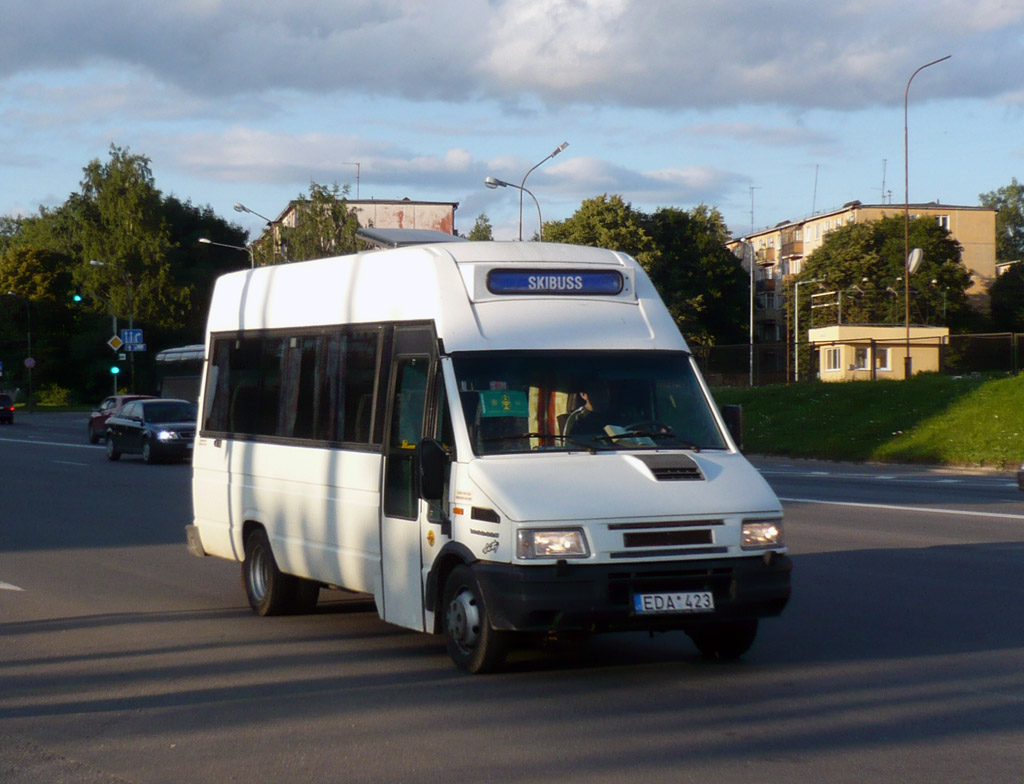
[106, 397, 197, 463]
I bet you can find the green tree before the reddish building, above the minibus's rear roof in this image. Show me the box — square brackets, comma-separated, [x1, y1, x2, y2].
[276, 182, 359, 261]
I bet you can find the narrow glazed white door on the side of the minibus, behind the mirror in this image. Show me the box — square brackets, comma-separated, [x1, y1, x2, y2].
[380, 326, 436, 630]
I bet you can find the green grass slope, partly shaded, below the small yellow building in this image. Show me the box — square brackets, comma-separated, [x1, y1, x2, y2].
[714, 374, 1024, 469]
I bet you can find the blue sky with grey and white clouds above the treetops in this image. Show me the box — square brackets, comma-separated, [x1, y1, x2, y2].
[0, 0, 1024, 238]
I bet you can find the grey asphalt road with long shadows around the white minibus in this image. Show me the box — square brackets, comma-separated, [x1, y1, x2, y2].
[0, 415, 1024, 784]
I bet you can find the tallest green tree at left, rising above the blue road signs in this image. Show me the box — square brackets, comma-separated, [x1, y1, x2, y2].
[75, 145, 190, 328]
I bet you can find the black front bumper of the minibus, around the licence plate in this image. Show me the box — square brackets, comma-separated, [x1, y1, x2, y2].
[473, 553, 793, 631]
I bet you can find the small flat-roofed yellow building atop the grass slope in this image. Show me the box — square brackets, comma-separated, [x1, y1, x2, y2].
[807, 325, 949, 381]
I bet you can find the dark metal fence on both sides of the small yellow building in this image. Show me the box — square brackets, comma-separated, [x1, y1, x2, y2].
[691, 333, 1024, 387]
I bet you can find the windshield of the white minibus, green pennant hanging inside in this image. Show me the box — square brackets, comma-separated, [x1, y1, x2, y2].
[452, 351, 727, 455]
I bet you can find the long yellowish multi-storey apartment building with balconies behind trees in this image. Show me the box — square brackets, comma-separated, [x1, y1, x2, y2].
[729, 202, 996, 342]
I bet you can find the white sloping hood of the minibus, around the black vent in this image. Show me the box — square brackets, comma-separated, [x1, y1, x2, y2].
[468, 450, 781, 523]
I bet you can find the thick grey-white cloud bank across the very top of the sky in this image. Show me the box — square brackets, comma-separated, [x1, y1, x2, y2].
[0, 0, 1024, 108]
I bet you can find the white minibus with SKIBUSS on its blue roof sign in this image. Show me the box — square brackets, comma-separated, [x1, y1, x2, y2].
[187, 242, 792, 672]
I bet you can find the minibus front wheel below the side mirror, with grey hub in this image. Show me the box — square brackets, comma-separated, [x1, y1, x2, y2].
[442, 566, 510, 673]
